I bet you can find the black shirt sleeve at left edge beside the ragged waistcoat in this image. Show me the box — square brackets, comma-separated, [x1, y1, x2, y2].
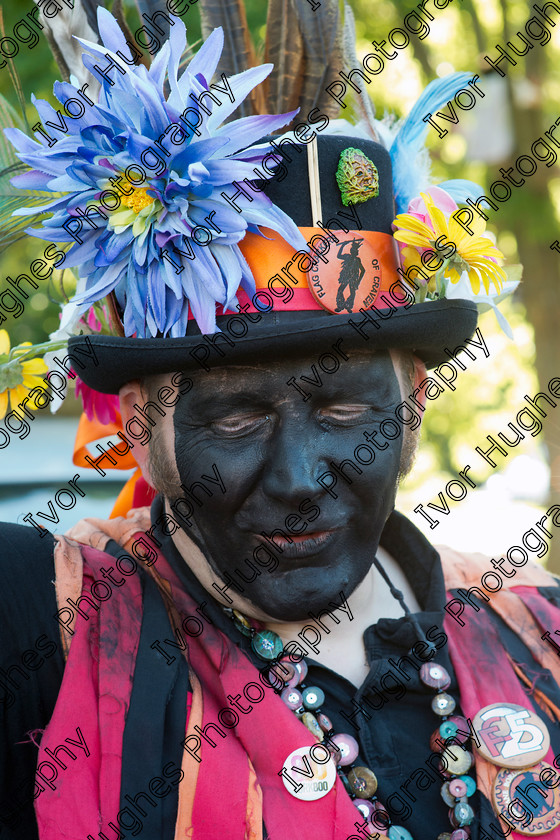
[0, 523, 64, 840]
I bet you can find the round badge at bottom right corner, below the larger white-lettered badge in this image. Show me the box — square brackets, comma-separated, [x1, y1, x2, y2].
[493, 761, 560, 834]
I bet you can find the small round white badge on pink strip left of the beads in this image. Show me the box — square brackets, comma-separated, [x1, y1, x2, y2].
[282, 744, 336, 802]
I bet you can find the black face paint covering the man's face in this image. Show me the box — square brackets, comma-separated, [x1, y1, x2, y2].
[174, 351, 402, 621]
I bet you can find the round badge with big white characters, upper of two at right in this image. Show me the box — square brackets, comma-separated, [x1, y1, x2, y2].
[472, 703, 550, 770]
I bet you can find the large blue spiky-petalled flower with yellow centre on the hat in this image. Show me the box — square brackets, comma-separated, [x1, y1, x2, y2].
[6, 8, 306, 337]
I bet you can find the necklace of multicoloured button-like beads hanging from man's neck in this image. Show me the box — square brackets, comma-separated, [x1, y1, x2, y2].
[223, 558, 477, 840]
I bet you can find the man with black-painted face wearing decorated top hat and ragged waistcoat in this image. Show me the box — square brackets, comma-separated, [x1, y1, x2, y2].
[0, 85, 560, 840]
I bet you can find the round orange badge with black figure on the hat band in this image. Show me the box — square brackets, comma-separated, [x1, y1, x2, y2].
[307, 230, 381, 314]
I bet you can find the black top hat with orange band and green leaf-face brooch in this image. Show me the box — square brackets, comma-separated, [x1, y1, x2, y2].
[69, 132, 477, 394]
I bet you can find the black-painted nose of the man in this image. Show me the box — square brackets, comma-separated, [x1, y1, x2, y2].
[263, 419, 326, 502]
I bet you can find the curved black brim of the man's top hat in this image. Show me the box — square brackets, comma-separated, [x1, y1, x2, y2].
[68, 299, 477, 394]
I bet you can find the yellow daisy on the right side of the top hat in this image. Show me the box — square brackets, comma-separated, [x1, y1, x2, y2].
[393, 193, 506, 295]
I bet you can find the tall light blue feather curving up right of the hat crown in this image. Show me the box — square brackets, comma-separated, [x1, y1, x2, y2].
[389, 73, 472, 213]
